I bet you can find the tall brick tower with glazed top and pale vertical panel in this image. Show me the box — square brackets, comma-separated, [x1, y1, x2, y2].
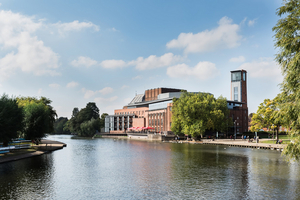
[230, 70, 248, 134]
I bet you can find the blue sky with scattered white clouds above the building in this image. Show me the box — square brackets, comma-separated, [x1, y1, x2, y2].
[0, 0, 282, 118]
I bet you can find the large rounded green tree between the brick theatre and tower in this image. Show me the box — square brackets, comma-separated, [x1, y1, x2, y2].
[171, 92, 231, 137]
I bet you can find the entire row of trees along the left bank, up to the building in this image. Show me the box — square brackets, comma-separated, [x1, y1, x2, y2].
[0, 94, 108, 146]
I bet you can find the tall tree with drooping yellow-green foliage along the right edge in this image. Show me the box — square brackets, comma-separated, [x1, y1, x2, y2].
[273, 0, 300, 160]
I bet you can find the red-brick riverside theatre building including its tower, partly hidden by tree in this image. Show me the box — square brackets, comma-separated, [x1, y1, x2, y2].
[105, 70, 248, 137]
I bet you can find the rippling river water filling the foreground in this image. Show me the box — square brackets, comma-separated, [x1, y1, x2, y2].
[0, 135, 300, 200]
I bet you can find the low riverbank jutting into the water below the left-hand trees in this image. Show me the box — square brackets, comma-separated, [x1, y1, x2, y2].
[0, 139, 67, 164]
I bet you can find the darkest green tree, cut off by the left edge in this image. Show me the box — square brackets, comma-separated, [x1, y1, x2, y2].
[0, 94, 24, 146]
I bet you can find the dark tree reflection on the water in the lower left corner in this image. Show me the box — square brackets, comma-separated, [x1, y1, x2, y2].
[0, 154, 53, 199]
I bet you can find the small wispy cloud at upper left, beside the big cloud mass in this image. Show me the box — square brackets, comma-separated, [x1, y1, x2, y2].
[53, 20, 100, 36]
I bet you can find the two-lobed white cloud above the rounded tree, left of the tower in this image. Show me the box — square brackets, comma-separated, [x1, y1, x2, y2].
[167, 62, 220, 80]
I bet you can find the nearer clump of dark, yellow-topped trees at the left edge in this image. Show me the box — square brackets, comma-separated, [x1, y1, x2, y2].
[0, 94, 57, 146]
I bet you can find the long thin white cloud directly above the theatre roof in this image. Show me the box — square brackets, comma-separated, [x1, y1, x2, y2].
[100, 53, 183, 70]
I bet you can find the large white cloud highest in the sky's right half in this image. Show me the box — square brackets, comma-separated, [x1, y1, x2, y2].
[166, 16, 242, 53]
